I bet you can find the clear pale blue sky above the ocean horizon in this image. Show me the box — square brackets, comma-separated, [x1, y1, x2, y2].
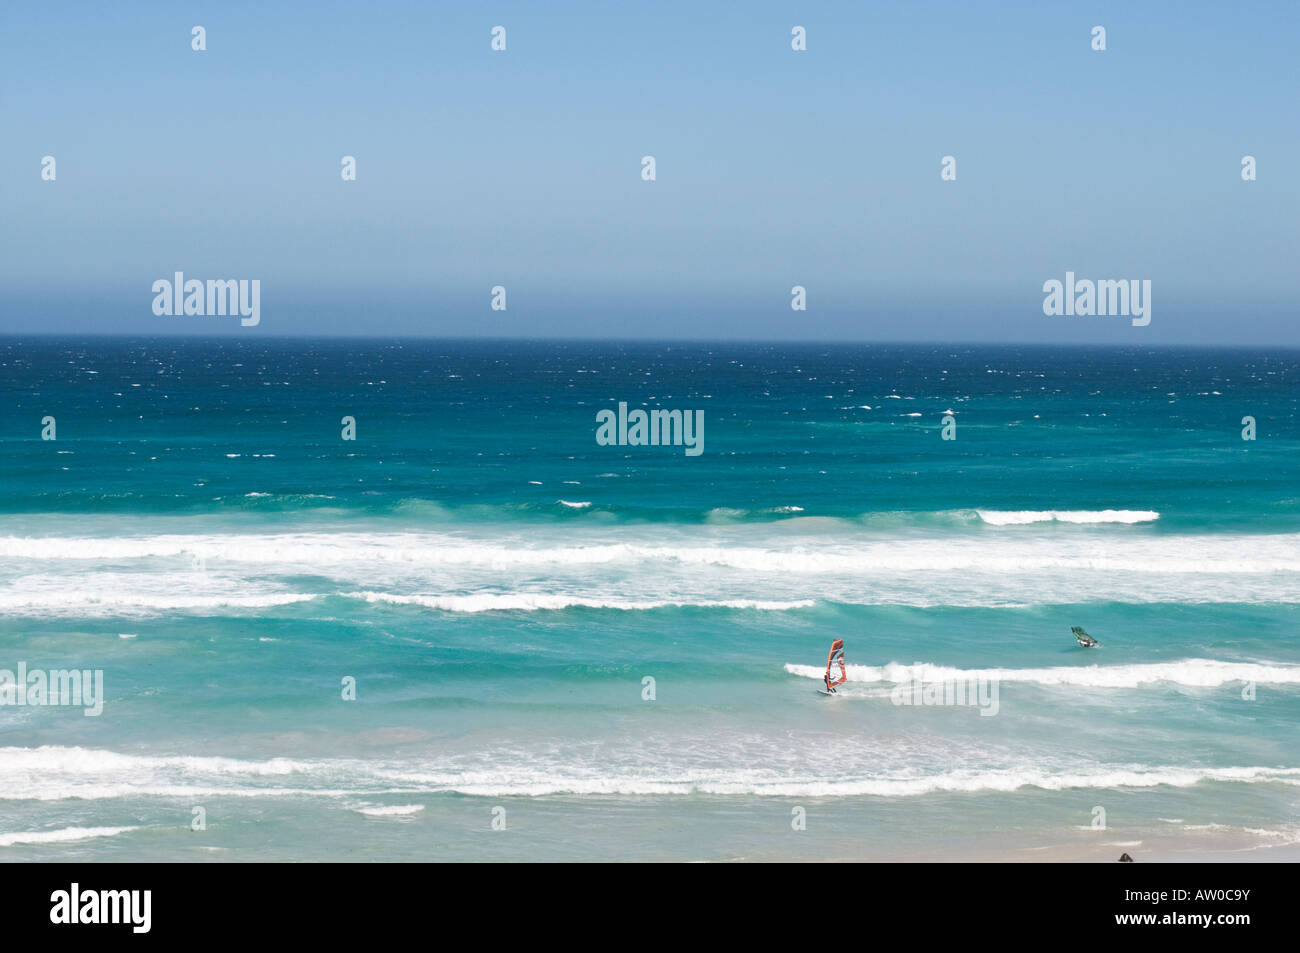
[0, 0, 1300, 346]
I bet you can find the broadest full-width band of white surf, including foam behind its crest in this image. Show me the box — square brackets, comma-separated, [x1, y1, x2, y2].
[0, 525, 1300, 605]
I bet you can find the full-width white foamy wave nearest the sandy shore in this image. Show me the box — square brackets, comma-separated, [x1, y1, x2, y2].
[0, 746, 1300, 800]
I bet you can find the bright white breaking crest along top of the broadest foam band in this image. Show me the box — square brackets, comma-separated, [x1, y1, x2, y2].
[10, 524, 1300, 576]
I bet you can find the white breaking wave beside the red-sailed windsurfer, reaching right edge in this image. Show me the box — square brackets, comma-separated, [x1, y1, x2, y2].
[785, 658, 1300, 688]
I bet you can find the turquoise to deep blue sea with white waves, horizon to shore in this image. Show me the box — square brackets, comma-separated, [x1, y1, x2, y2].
[0, 337, 1300, 859]
